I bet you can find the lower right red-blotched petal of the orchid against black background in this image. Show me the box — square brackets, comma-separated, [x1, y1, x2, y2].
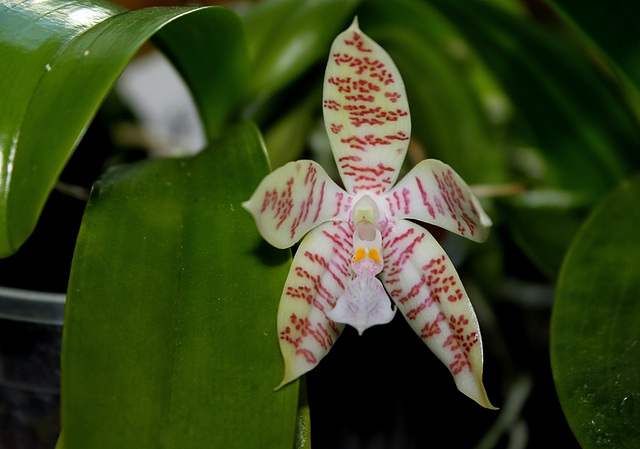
[381, 220, 494, 408]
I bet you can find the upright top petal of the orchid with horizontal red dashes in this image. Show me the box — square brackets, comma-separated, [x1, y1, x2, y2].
[323, 20, 411, 195]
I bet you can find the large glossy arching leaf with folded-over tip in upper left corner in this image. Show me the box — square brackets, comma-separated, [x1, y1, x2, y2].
[0, 0, 248, 256]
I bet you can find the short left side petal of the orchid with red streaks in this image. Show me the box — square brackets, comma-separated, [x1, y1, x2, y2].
[242, 160, 353, 248]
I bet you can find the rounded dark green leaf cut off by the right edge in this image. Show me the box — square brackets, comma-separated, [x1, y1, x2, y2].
[551, 173, 640, 449]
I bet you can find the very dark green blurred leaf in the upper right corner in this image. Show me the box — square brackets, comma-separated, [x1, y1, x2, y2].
[430, 0, 640, 198]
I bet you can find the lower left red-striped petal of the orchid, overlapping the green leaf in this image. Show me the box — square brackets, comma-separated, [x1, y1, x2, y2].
[278, 222, 353, 385]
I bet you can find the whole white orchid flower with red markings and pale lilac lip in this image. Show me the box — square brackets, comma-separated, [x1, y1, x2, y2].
[243, 19, 493, 408]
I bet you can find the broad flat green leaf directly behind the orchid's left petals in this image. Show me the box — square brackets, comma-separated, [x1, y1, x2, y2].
[59, 121, 298, 449]
